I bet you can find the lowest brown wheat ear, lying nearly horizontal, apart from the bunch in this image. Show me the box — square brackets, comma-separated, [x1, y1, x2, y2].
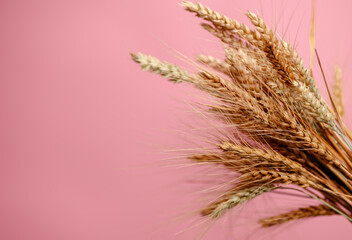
[259, 205, 337, 227]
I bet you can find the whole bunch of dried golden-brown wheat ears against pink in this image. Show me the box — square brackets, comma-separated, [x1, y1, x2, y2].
[131, 2, 352, 227]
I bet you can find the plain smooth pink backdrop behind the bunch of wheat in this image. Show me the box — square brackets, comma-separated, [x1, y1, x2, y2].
[0, 0, 352, 240]
